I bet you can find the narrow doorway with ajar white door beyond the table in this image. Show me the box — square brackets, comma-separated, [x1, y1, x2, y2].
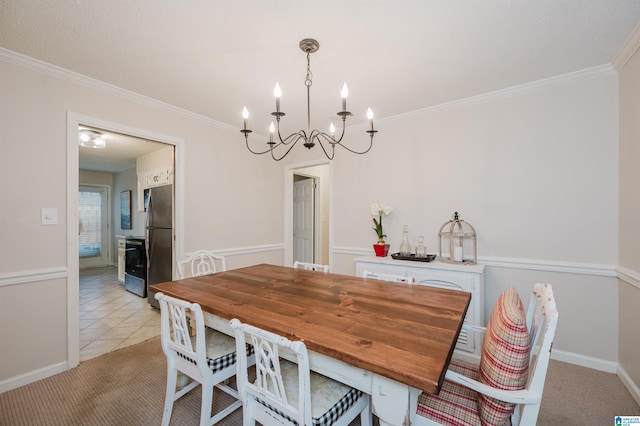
[284, 160, 331, 266]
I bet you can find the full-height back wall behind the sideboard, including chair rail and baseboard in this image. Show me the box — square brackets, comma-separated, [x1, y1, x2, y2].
[324, 68, 618, 371]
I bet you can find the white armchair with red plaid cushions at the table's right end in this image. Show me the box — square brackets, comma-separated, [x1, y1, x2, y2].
[414, 284, 558, 426]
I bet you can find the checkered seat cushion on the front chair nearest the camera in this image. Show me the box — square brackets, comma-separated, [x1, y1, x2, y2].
[258, 360, 364, 426]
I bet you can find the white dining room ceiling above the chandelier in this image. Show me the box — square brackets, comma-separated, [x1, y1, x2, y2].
[0, 0, 640, 170]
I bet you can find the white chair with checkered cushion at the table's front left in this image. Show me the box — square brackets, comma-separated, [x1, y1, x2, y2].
[155, 292, 254, 426]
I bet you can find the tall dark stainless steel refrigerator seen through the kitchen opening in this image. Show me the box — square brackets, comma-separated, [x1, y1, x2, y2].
[145, 185, 173, 309]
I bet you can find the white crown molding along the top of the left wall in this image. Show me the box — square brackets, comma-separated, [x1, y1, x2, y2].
[0, 47, 239, 131]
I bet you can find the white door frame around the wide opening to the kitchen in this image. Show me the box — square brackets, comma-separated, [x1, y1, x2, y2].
[66, 111, 185, 369]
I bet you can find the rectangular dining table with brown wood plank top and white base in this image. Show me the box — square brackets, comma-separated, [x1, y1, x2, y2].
[151, 264, 471, 425]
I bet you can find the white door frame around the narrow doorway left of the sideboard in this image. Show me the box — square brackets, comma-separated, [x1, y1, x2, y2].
[283, 159, 333, 266]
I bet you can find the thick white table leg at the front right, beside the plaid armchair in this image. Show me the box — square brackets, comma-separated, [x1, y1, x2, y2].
[371, 374, 420, 426]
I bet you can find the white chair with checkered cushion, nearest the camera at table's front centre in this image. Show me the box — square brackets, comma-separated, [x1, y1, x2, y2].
[230, 318, 372, 426]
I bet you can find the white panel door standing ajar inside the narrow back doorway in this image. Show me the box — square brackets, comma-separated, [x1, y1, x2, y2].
[293, 175, 315, 263]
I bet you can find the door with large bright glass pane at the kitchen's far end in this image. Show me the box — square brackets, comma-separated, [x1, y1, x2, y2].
[78, 186, 111, 268]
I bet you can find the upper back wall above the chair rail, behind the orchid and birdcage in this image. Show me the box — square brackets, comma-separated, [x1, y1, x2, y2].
[334, 72, 618, 265]
